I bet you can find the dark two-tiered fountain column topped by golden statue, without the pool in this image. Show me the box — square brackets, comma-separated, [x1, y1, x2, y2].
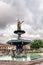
[7, 20, 30, 54]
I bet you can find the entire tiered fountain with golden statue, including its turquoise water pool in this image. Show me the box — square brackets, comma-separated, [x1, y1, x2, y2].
[0, 21, 43, 62]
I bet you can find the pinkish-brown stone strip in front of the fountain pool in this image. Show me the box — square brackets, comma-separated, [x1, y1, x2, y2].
[0, 59, 43, 65]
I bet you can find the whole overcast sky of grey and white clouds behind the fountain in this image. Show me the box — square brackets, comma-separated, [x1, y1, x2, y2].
[0, 0, 43, 43]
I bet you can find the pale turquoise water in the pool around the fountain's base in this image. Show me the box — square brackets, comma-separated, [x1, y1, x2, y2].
[0, 55, 42, 61]
